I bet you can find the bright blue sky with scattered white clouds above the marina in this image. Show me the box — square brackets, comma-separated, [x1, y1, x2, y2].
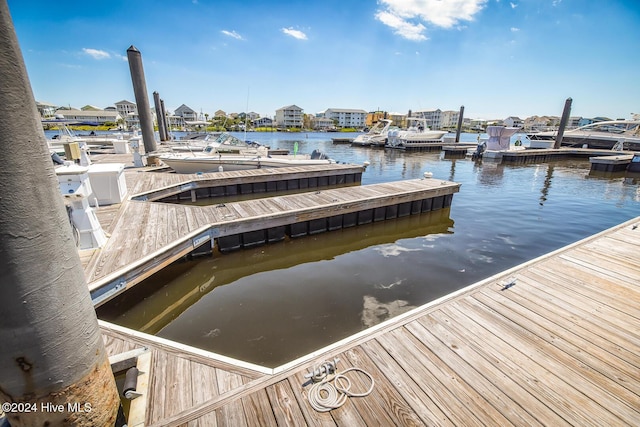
[8, 0, 640, 119]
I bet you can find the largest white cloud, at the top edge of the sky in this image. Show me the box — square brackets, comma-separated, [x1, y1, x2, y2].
[375, 0, 487, 41]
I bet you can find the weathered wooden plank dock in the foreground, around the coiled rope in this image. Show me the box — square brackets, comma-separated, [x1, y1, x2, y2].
[101, 217, 640, 426]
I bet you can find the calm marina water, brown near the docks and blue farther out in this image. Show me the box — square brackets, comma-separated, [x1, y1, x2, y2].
[98, 133, 640, 367]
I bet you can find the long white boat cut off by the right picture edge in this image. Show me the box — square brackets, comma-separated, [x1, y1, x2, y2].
[527, 120, 640, 151]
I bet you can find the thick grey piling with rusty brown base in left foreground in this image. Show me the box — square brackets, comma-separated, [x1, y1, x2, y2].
[0, 0, 120, 427]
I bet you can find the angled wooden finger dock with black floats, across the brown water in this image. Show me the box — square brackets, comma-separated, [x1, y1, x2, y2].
[83, 165, 460, 305]
